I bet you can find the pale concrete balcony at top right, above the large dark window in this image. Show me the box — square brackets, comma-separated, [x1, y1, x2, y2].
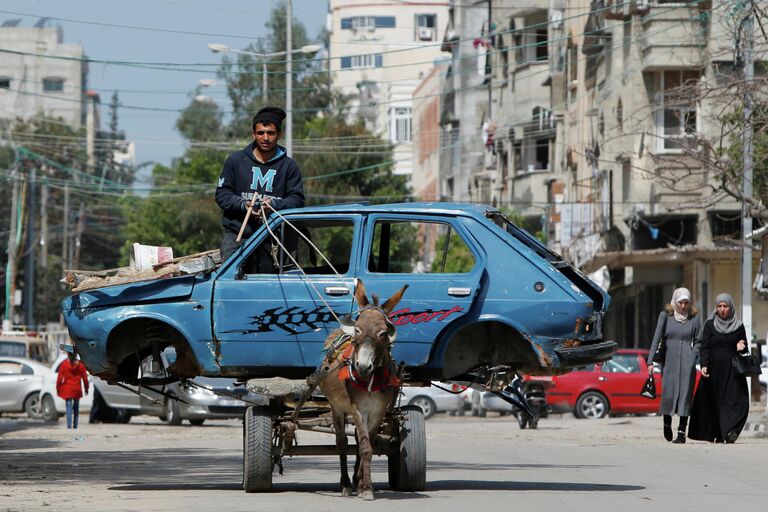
[637, 4, 707, 71]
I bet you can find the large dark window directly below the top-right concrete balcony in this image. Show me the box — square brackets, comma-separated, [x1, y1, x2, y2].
[656, 69, 699, 151]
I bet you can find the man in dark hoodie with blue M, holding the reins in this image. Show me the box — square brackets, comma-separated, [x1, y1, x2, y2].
[216, 107, 304, 262]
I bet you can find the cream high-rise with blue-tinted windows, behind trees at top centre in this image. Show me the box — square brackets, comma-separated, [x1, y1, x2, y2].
[328, 0, 448, 176]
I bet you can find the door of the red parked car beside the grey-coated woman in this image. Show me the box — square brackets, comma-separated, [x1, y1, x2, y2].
[598, 354, 648, 411]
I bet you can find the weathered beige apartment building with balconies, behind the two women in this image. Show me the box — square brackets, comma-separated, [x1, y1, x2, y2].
[491, 0, 768, 347]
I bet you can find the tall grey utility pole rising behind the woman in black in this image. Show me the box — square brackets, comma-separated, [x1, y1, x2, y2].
[740, 3, 755, 400]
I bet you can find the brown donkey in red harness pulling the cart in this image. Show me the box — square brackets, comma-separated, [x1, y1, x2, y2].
[319, 280, 408, 501]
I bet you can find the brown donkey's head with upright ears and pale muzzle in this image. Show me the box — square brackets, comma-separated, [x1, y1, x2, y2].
[342, 280, 408, 379]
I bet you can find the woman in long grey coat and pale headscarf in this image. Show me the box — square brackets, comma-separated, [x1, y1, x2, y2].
[648, 288, 701, 443]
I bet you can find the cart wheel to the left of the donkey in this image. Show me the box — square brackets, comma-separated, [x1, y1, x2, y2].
[243, 407, 272, 492]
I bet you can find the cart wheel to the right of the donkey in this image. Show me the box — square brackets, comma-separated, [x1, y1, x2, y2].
[388, 405, 427, 491]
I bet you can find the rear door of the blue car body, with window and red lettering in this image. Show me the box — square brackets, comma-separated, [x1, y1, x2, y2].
[359, 214, 485, 366]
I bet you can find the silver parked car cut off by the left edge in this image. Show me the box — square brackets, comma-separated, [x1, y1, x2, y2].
[0, 356, 49, 418]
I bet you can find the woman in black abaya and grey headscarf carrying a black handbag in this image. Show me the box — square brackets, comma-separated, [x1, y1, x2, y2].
[688, 293, 749, 443]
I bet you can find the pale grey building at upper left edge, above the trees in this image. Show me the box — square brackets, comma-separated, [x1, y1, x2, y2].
[0, 18, 88, 126]
